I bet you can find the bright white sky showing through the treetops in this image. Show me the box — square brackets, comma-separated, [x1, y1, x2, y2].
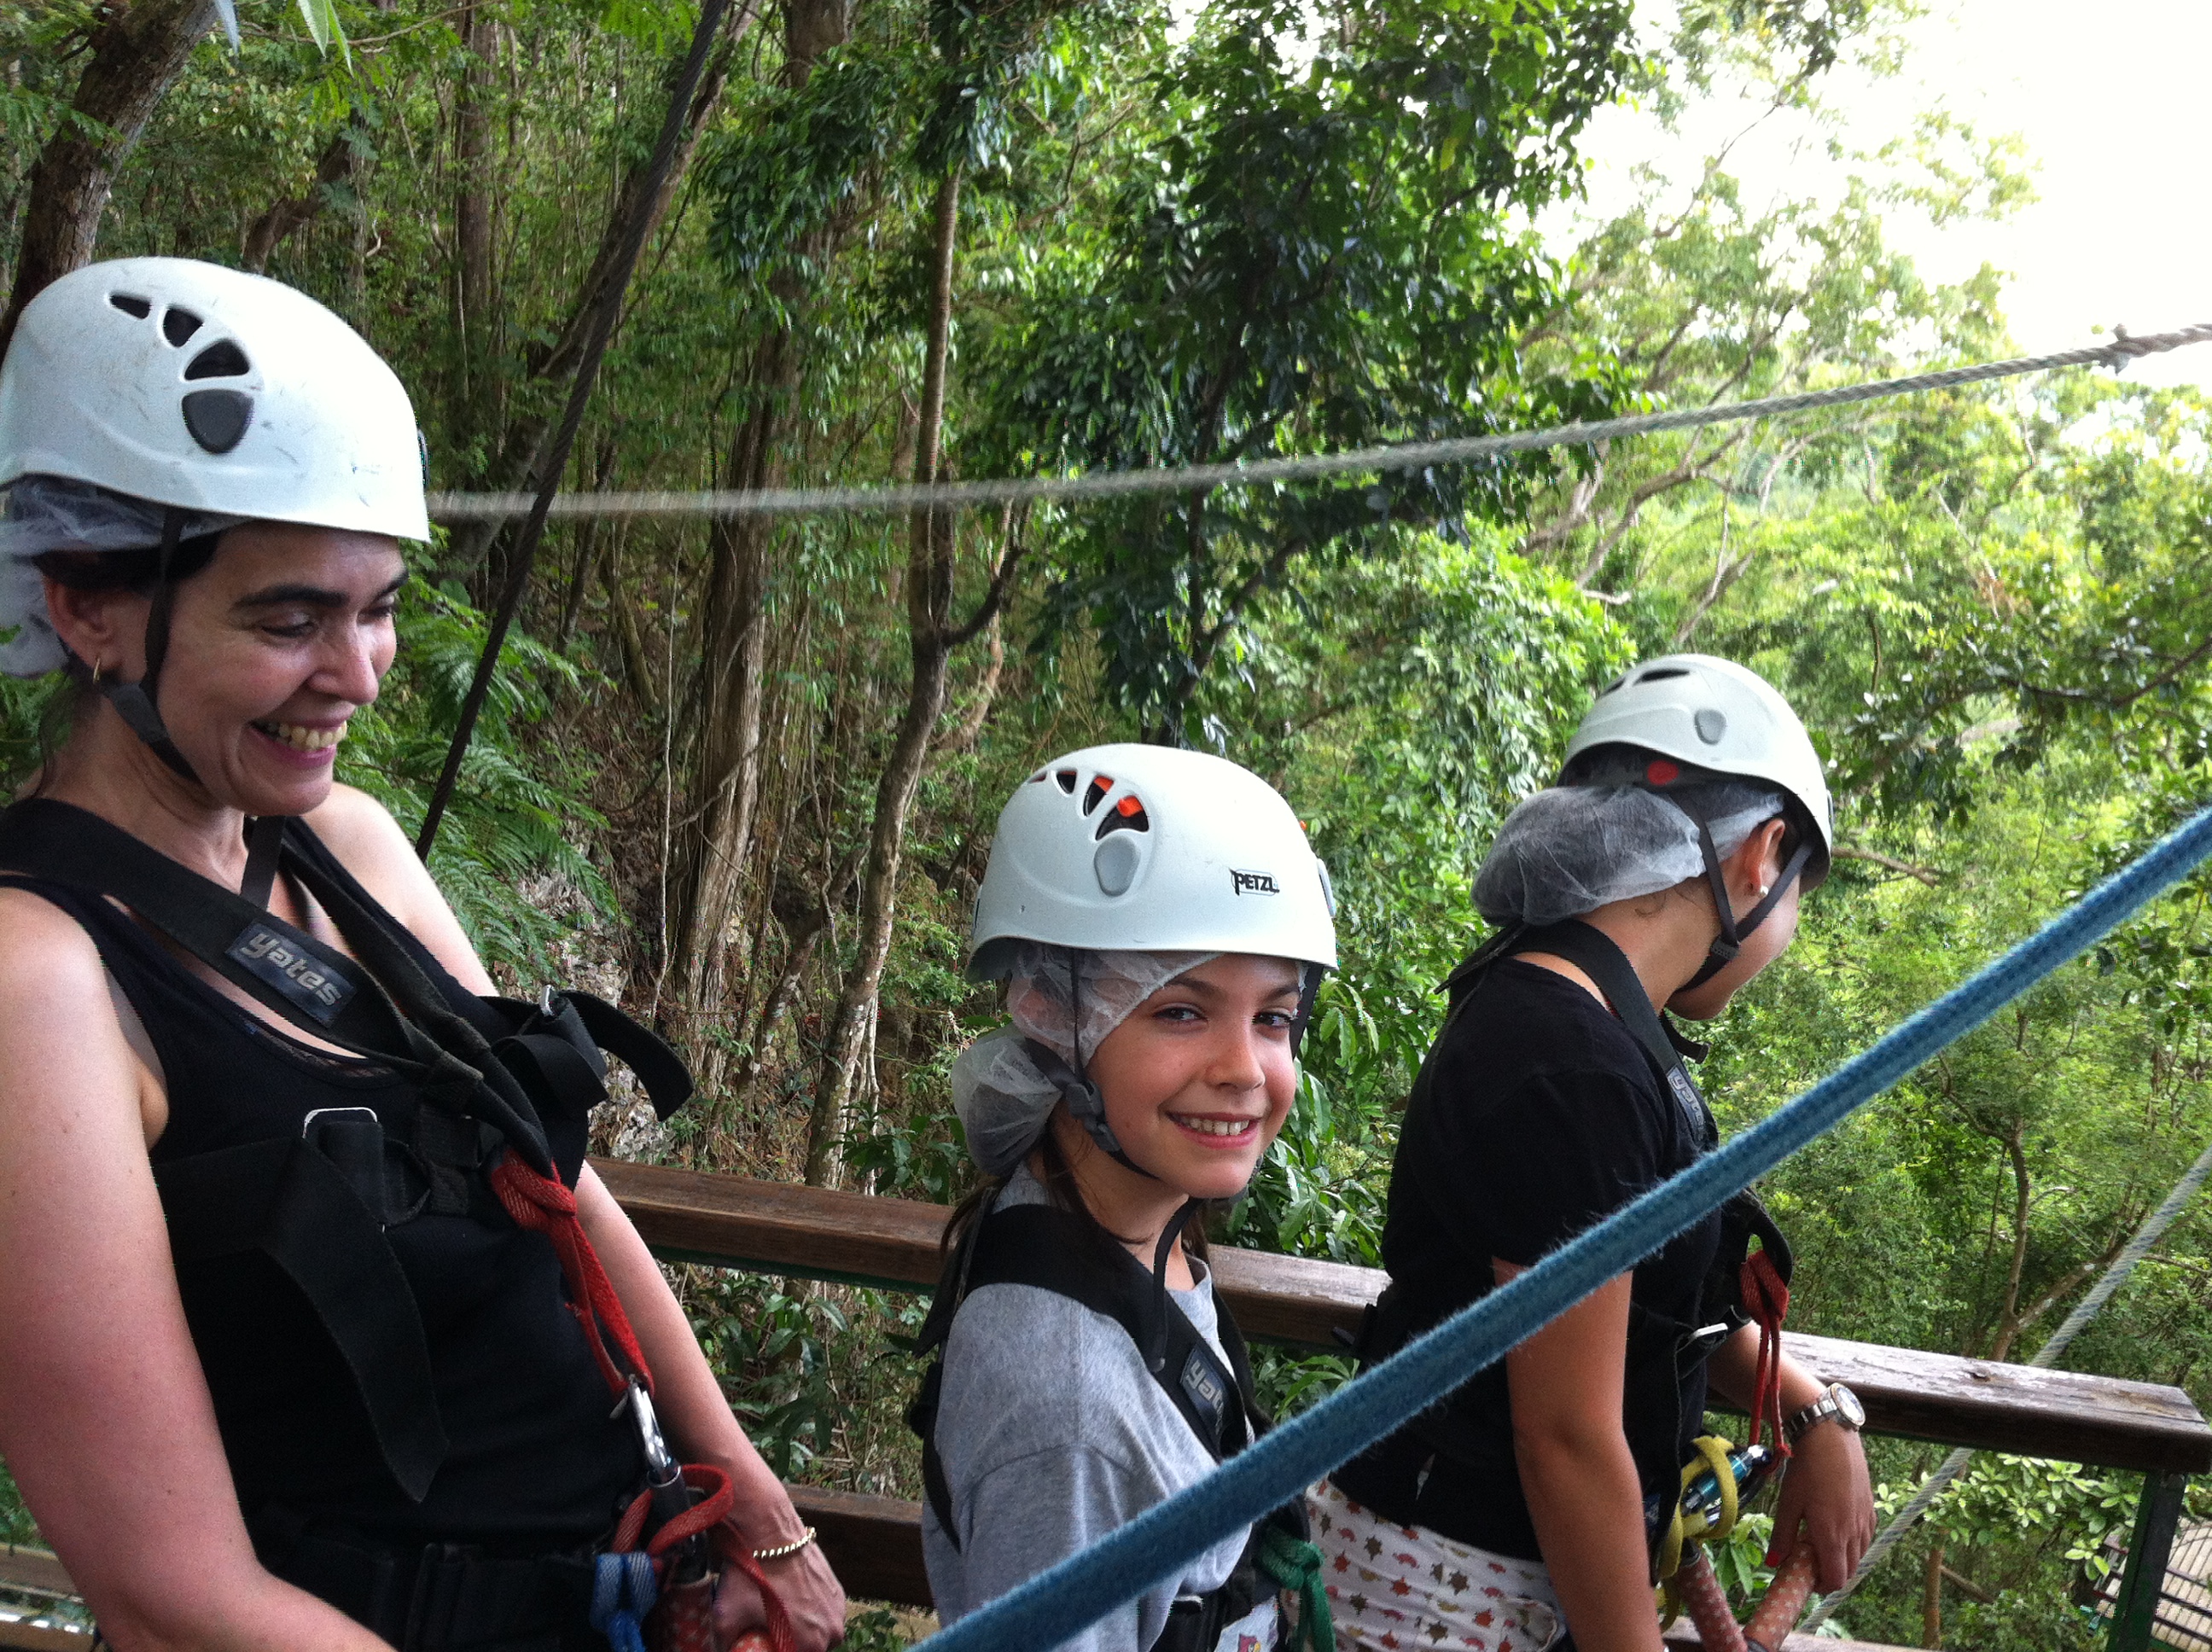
[1557, 0, 2212, 387]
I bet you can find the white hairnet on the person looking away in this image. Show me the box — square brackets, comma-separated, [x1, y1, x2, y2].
[1476, 782, 1783, 927]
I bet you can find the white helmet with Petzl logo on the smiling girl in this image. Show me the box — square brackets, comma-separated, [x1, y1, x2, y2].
[969, 745, 1336, 980]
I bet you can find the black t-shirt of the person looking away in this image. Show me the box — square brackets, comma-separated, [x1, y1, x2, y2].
[1336, 957, 1721, 1559]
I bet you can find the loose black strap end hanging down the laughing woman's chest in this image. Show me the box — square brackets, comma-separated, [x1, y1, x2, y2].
[154, 1121, 449, 1502]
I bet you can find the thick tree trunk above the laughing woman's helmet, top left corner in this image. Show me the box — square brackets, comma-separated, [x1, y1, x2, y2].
[0, 0, 214, 352]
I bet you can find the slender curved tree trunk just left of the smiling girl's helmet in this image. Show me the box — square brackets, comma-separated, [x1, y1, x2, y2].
[807, 166, 960, 1188]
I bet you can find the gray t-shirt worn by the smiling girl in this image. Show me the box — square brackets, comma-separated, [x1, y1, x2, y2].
[923, 1170, 1274, 1652]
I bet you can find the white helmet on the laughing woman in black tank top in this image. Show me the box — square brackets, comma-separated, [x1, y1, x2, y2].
[0, 259, 429, 539]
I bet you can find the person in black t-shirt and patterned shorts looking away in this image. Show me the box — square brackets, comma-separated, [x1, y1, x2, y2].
[1307, 654, 1873, 1652]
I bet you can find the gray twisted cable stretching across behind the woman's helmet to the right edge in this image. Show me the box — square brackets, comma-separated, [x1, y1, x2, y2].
[429, 323, 2212, 522]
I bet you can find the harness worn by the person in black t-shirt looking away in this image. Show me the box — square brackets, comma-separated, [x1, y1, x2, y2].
[1358, 913, 1792, 1581]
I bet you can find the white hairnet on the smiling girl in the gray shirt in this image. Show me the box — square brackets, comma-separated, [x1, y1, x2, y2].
[953, 942, 1219, 1177]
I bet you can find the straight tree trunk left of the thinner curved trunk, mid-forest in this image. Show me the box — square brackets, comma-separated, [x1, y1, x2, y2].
[666, 0, 852, 1066]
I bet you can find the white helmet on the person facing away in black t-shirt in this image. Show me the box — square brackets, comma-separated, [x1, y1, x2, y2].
[1566, 654, 1836, 885]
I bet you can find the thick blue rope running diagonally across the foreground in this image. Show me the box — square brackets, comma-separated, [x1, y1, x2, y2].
[927, 810, 2212, 1652]
